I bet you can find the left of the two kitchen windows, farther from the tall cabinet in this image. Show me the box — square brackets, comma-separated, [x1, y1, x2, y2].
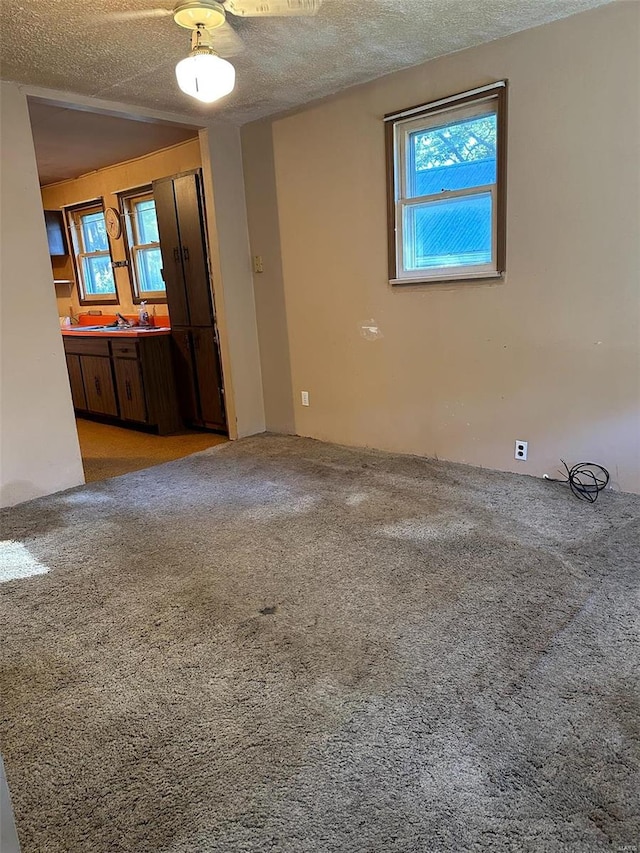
[67, 201, 118, 305]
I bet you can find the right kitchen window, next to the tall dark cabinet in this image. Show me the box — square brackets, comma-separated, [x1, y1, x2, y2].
[120, 188, 167, 303]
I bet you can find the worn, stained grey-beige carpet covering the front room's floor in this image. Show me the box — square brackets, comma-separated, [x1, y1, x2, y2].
[0, 436, 640, 853]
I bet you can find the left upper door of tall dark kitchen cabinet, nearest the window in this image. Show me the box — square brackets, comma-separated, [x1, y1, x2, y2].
[153, 178, 189, 326]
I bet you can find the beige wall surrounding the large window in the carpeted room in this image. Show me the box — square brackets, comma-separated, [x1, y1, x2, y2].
[243, 2, 640, 491]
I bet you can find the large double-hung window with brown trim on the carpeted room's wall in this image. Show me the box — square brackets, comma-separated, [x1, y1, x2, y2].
[385, 81, 506, 284]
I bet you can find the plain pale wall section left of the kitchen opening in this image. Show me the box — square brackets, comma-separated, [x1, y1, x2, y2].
[0, 83, 84, 506]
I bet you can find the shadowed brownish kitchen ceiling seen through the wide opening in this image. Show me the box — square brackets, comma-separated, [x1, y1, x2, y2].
[29, 101, 198, 185]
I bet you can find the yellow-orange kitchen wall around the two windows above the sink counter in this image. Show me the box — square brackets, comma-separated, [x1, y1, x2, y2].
[42, 137, 201, 317]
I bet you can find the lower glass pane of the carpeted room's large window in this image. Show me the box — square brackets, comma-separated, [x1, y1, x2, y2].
[403, 193, 492, 270]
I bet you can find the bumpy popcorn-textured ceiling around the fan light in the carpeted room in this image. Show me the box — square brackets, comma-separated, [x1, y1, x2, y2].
[0, 0, 609, 124]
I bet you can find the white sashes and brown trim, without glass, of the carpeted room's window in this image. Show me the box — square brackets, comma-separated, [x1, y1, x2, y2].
[385, 81, 506, 284]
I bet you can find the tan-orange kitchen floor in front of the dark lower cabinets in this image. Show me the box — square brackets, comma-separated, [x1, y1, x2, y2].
[76, 418, 228, 483]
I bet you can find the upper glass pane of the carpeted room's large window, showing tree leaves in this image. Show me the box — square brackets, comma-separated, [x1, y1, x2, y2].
[407, 113, 498, 198]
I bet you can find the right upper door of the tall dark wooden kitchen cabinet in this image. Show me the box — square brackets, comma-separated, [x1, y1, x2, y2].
[174, 174, 213, 326]
